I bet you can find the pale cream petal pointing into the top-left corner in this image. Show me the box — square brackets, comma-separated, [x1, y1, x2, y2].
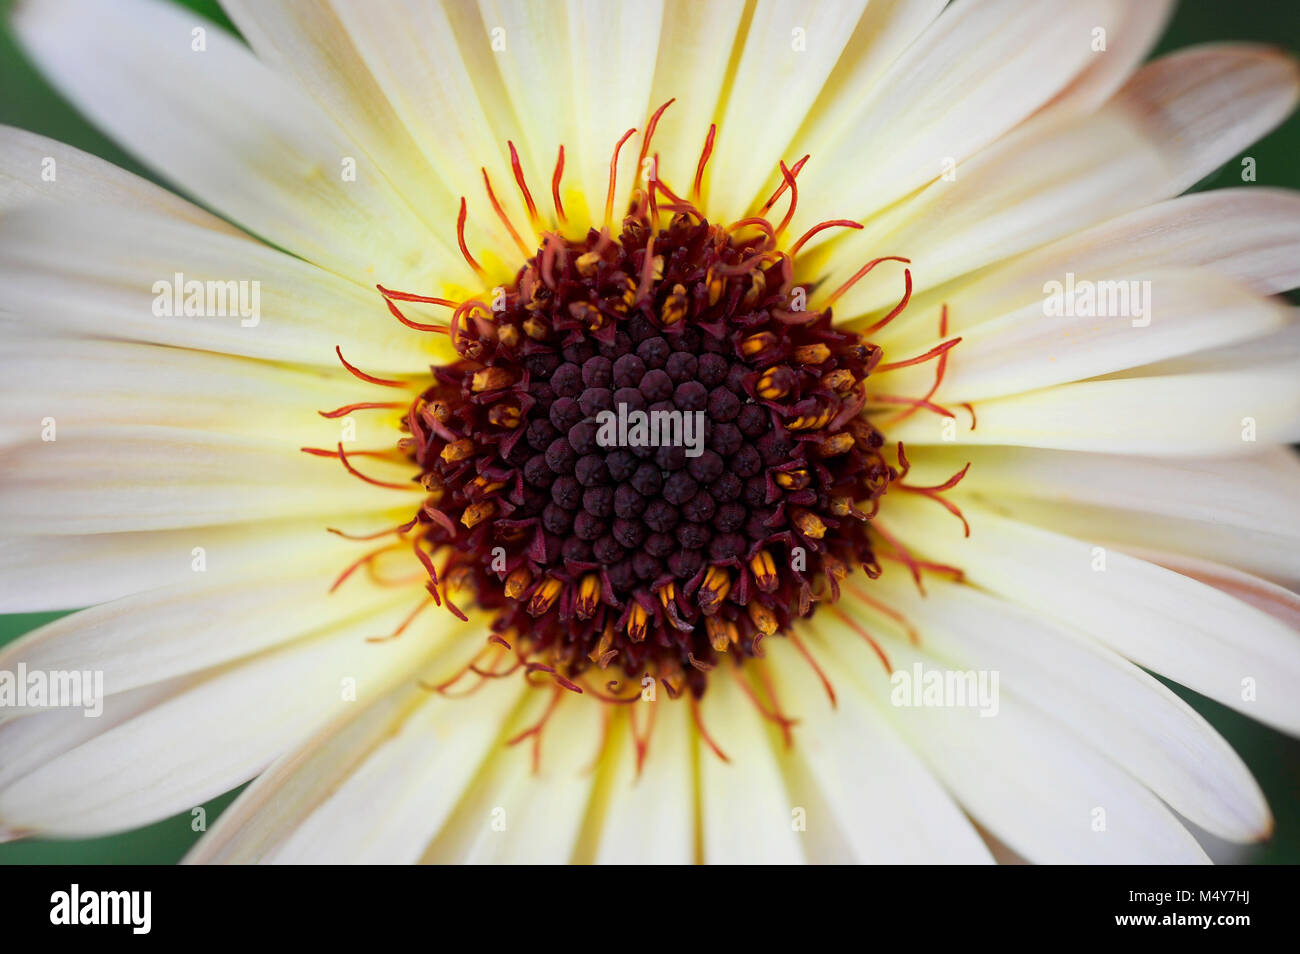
[13, 0, 462, 291]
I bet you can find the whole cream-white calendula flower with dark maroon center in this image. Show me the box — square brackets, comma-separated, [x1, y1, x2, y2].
[0, 0, 1300, 862]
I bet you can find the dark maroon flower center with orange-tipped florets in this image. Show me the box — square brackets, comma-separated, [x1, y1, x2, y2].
[403, 201, 896, 695]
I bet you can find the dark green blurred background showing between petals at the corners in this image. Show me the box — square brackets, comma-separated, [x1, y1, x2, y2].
[0, 0, 1300, 864]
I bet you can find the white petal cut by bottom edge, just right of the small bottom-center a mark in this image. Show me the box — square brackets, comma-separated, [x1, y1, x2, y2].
[763, 639, 993, 864]
